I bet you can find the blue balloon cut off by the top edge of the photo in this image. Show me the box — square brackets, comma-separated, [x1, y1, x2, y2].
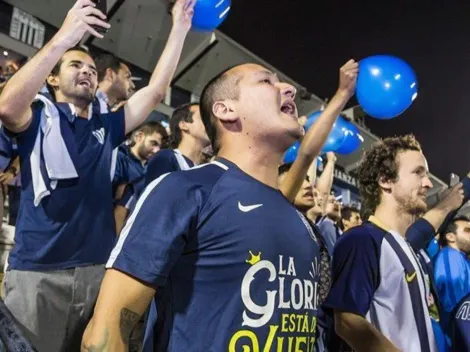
[192, 0, 231, 32]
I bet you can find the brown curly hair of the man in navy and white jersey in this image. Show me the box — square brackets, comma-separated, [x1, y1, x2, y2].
[358, 134, 421, 218]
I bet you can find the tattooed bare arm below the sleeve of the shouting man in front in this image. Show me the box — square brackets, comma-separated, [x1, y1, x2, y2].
[81, 269, 155, 352]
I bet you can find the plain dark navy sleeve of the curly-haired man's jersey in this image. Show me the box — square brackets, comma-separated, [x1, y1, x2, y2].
[324, 228, 380, 317]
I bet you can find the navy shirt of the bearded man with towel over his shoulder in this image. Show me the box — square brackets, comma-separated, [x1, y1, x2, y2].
[6, 99, 125, 270]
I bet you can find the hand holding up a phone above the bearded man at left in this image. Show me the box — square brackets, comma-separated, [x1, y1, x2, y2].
[55, 0, 111, 49]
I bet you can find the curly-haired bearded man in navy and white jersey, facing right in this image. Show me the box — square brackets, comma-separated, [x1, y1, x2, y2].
[325, 135, 438, 352]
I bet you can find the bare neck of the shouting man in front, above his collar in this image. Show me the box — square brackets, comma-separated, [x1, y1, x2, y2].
[217, 143, 282, 189]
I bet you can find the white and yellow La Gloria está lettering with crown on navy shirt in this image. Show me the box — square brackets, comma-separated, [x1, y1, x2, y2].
[228, 251, 319, 352]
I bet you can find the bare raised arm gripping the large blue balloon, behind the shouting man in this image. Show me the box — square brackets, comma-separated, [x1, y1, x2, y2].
[280, 60, 359, 201]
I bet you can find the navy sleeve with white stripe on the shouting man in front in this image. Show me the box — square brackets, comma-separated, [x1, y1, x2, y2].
[107, 173, 201, 287]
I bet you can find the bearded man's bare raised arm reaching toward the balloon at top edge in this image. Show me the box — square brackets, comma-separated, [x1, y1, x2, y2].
[124, 0, 196, 134]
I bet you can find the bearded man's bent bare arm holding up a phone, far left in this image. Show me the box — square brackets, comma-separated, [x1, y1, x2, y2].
[0, 0, 109, 132]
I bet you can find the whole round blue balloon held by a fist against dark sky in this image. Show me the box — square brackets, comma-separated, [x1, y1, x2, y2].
[356, 55, 418, 120]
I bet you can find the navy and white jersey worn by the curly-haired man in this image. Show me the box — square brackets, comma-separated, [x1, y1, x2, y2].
[324, 222, 438, 352]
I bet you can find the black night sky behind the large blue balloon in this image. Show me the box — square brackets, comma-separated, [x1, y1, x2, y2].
[220, 0, 470, 183]
